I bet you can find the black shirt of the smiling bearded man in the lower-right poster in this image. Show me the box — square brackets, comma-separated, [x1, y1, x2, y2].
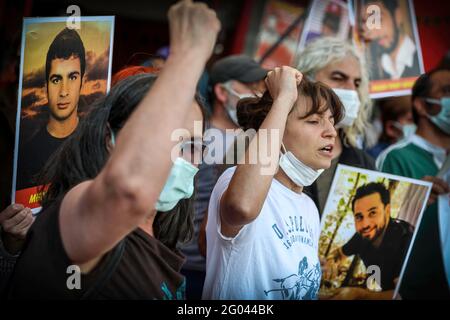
[342, 218, 414, 290]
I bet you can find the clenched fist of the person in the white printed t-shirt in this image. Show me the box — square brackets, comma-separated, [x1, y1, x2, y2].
[265, 66, 303, 111]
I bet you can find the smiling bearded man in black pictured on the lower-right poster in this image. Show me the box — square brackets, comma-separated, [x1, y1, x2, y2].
[331, 182, 414, 294]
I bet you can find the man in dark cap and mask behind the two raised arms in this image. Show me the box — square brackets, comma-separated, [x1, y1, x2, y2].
[182, 55, 268, 299]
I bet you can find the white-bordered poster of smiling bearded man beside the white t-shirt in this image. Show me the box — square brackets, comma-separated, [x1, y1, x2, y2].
[319, 165, 431, 300]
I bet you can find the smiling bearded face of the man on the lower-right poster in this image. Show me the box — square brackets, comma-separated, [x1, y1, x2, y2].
[353, 192, 390, 241]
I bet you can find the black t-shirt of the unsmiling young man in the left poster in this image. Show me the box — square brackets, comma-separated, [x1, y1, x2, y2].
[16, 124, 67, 190]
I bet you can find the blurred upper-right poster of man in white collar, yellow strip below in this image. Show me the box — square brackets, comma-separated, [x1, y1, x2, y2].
[354, 0, 424, 98]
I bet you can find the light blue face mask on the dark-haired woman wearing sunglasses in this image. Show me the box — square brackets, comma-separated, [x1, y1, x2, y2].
[111, 130, 198, 212]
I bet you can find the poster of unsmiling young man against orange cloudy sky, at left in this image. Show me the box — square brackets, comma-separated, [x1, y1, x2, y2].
[12, 16, 114, 212]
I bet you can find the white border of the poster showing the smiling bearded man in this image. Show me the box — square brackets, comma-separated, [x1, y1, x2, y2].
[320, 164, 432, 299]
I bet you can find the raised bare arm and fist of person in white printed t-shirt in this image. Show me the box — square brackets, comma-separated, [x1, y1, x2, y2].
[220, 67, 302, 237]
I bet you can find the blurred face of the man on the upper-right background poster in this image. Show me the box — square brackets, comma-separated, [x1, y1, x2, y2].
[361, 1, 399, 53]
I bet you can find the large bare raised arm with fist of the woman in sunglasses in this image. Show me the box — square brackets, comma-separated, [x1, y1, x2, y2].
[60, 1, 220, 264]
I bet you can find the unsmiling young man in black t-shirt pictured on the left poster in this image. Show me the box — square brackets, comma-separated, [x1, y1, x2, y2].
[17, 28, 86, 189]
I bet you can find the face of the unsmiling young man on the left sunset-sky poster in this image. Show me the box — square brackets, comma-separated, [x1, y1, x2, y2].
[47, 55, 82, 121]
